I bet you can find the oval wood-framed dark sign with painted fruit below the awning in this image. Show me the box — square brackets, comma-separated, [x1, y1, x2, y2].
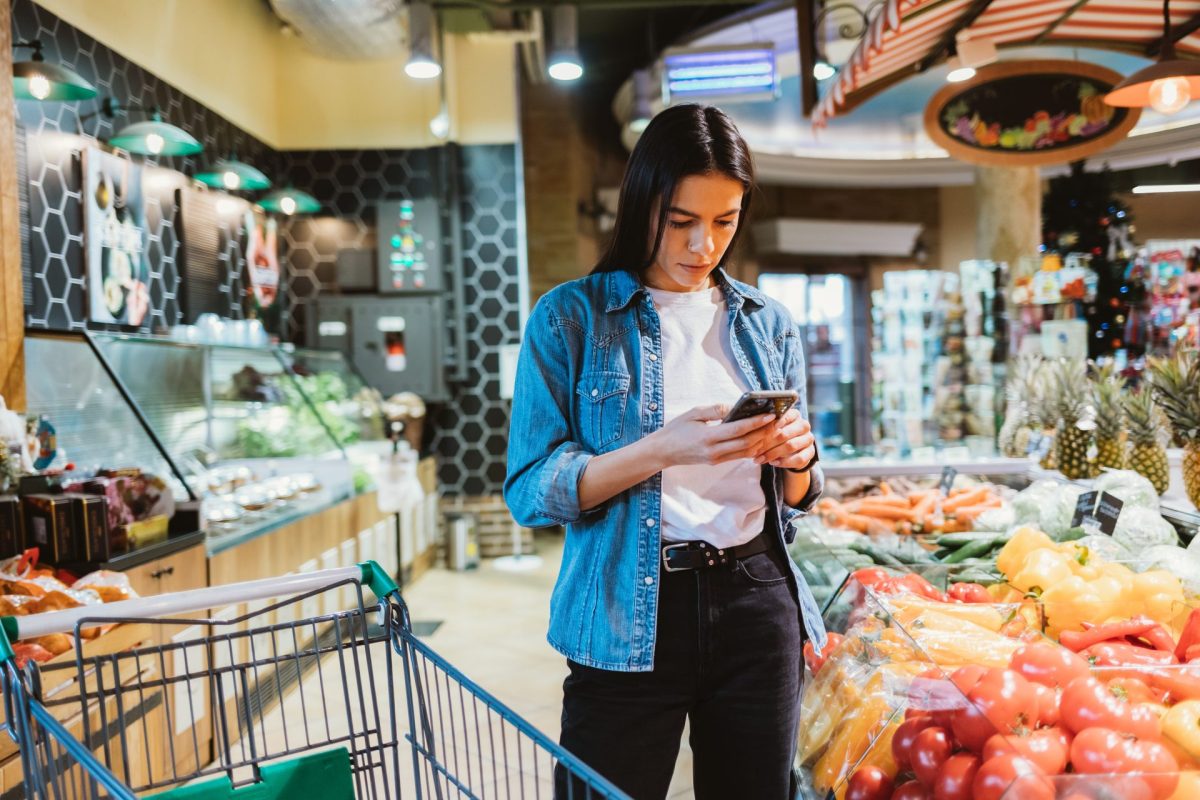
[925, 61, 1141, 167]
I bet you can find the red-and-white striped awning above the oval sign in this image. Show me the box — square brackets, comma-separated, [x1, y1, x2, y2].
[812, 0, 1200, 125]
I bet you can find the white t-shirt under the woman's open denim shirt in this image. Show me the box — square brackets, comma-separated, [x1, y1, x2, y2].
[649, 287, 767, 548]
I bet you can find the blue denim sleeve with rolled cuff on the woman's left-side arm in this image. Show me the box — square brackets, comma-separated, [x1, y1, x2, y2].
[504, 299, 594, 528]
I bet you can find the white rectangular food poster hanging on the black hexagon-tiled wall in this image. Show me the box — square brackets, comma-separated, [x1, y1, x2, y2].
[80, 148, 150, 327]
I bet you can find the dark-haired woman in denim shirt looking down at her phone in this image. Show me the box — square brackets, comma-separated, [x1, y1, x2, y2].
[505, 106, 824, 800]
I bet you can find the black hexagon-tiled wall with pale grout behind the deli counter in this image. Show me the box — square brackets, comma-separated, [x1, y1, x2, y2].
[8, 0, 518, 494]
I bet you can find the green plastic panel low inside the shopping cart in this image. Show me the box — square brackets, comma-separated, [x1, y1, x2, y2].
[148, 747, 354, 800]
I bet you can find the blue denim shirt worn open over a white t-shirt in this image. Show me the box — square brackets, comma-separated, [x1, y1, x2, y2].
[504, 271, 826, 672]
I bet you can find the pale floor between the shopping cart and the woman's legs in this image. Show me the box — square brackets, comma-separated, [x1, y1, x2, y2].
[404, 535, 692, 798]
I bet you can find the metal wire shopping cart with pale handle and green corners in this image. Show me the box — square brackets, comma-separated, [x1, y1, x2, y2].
[0, 563, 626, 800]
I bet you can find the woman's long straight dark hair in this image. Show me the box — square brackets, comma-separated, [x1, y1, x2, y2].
[592, 103, 754, 272]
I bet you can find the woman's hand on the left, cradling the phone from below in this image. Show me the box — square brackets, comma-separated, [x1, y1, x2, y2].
[648, 405, 775, 468]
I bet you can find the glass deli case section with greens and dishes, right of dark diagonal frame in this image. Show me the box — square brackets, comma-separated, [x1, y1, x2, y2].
[91, 332, 365, 551]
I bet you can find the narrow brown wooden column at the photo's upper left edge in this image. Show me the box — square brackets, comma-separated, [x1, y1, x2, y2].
[0, 0, 25, 410]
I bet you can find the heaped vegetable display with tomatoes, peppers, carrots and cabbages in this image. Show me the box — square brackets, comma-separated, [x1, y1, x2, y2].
[792, 462, 1200, 800]
